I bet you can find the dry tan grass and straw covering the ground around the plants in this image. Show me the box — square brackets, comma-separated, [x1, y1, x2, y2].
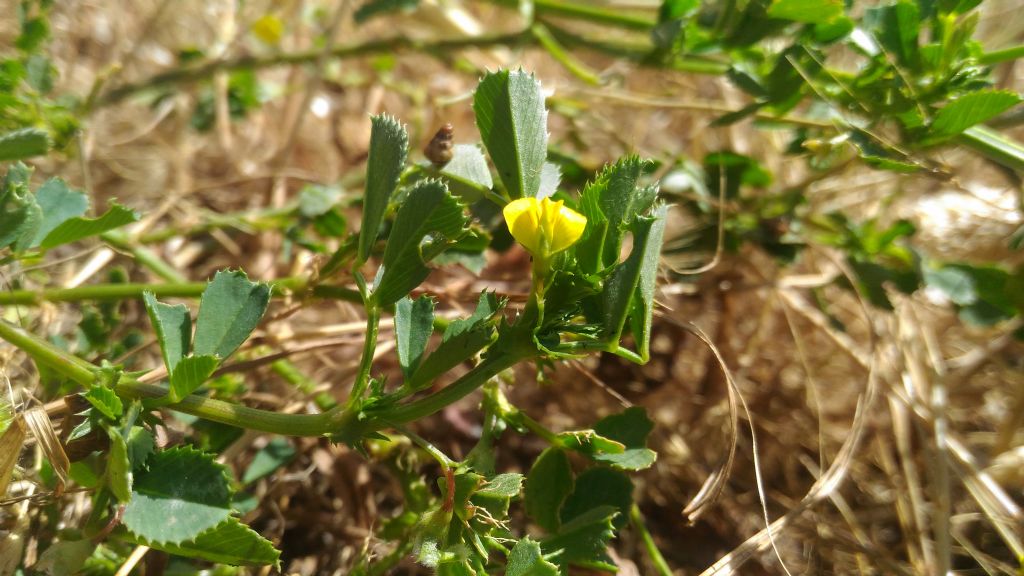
[0, 0, 1024, 574]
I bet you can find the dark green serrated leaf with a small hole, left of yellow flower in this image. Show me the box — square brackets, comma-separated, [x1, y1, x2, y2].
[372, 179, 467, 306]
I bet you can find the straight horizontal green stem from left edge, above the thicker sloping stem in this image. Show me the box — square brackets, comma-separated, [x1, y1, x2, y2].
[0, 278, 362, 305]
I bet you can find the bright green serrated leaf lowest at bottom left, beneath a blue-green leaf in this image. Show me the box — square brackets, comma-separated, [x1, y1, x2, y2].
[115, 518, 281, 566]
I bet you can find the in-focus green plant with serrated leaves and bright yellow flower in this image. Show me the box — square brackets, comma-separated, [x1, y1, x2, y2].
[0, 71, 666, 574]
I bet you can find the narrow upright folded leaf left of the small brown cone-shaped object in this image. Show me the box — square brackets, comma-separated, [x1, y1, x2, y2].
[358, 114, 409, 263]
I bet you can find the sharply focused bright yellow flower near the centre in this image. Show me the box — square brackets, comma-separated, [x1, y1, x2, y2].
[503, 198, 587, 259]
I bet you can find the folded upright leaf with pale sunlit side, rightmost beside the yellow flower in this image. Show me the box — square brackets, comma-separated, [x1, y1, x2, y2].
[602, 212, 665, 349]
